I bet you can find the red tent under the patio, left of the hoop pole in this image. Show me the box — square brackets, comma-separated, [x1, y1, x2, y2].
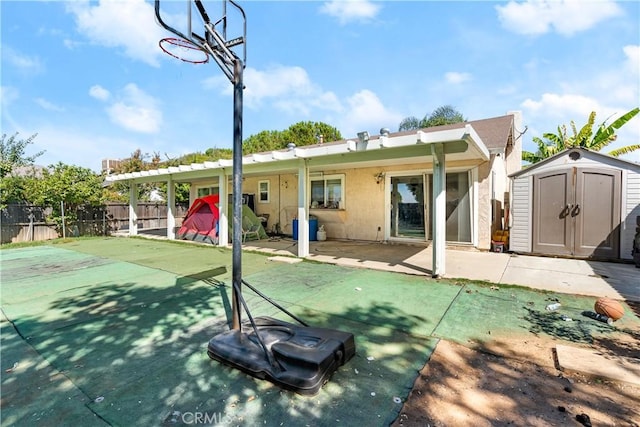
[177, 194, 220, 244]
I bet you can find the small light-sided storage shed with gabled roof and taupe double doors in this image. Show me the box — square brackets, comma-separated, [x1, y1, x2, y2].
[509, 148, 640, 260]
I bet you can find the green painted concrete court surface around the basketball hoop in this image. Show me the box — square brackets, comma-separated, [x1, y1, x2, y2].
[0, 238, 640, 426]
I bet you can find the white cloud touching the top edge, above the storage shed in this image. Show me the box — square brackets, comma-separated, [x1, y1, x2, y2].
[496, 0, 621, 36]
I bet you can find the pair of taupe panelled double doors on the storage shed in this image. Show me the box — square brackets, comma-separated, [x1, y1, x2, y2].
[533, 168, 621, 259]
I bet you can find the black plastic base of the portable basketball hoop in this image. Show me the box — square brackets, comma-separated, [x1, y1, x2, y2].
[207, 317, 356, 395]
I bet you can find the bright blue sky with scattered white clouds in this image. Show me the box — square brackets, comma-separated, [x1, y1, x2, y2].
[0, 0, 640, 171]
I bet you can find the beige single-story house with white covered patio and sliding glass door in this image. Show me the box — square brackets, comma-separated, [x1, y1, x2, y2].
[106, 112, 523, 276]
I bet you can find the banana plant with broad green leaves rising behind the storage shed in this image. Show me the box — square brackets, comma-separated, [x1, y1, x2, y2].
[522, 108, 640, 163]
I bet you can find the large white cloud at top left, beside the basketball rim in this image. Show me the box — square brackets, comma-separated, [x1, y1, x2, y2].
[65, 0, 166, 66]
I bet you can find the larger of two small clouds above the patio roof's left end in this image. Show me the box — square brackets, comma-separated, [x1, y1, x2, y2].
[107, 83, 162, 133]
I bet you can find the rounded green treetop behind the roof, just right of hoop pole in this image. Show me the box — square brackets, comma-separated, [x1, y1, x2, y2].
[242, 122, 342, 154]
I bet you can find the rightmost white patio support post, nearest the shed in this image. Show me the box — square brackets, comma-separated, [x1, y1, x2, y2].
[431, 143, 447, 278]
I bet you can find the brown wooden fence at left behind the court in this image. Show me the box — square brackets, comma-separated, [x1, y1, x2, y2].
[0, 202, 188, 244]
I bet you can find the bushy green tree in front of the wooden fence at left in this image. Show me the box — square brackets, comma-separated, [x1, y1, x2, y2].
[28, 162, 104, 236]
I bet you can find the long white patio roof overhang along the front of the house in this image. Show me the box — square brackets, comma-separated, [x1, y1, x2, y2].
[105, 124, 490, 184]
